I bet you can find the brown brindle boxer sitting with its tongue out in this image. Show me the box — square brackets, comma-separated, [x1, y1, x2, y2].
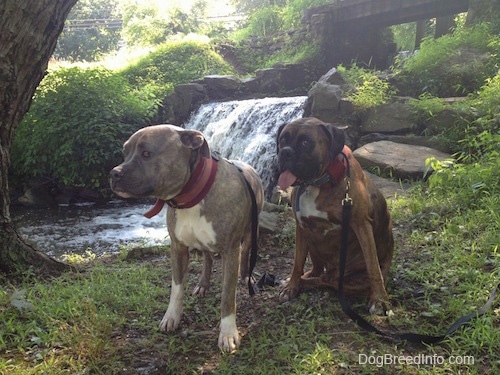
[277, 117, 393, 314]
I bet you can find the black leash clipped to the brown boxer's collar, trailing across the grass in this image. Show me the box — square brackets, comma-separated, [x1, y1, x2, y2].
[338, 159, 500, 344]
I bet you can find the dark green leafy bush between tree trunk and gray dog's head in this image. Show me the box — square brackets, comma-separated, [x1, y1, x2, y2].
[11, 67, 157, 191]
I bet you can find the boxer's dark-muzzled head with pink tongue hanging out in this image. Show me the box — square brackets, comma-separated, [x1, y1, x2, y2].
[277, 117, 345, 189]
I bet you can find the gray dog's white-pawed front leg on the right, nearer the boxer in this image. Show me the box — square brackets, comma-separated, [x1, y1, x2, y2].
[219, 250, 240, 352]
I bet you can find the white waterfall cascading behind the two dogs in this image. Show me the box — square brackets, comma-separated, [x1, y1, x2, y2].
[185, 96, 307, 197]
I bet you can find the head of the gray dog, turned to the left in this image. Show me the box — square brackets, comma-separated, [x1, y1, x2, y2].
[110, 125, 210, 200]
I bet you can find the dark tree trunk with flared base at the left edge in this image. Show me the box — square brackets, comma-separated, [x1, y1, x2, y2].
[0, 0, 77, 273]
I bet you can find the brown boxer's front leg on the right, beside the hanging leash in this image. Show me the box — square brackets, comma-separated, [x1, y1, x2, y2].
[351, 221, 392, 315]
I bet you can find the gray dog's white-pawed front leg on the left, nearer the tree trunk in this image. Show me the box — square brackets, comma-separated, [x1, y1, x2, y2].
[160, 243, 189, 332]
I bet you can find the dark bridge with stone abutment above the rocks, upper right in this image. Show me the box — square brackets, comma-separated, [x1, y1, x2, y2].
[303, 0, 469, 69]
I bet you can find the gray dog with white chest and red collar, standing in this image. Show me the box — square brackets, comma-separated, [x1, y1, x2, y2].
[110, 125, 264, 352]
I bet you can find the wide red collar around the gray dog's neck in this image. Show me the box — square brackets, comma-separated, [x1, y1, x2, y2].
[144, 156, 217, 219]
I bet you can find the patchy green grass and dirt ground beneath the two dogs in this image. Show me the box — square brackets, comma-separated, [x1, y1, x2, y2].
[0, 177, 500, 375]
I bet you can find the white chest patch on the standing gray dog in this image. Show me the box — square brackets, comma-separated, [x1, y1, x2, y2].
[174, 204, 217, 250]
